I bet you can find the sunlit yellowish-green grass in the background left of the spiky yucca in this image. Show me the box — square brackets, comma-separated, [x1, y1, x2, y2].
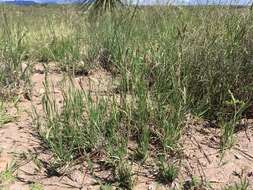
[0, 5, 88, 77]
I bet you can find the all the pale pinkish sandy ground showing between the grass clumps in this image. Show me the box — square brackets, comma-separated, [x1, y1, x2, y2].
[0, 65, 253, 190]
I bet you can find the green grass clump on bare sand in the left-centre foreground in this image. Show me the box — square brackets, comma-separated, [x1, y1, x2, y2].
[37, 78, 121, 163]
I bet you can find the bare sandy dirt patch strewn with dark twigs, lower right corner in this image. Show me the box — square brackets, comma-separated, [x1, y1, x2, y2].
[182, 116, 253, 189]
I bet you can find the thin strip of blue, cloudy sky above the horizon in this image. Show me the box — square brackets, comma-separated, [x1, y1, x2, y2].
[0, 0, 253, 5]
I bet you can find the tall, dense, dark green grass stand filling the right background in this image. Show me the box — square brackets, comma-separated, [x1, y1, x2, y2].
[87, 8, 252, 118]
